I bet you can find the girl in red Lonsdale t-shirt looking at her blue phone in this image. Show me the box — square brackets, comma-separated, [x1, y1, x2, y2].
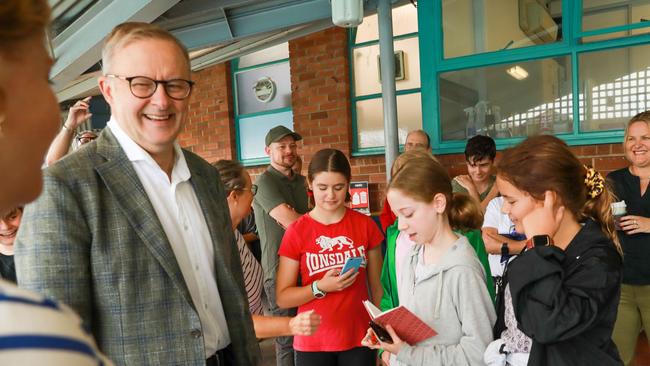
[276, 149, 383, 366]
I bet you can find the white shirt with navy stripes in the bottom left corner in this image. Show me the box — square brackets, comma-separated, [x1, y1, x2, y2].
[0, 280, 113, 366]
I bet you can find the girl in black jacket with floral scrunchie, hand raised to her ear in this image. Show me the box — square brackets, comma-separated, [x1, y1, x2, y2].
[485, 136, 622, 366]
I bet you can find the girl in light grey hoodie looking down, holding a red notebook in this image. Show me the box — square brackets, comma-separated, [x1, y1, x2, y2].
[362, 154, 496, 366]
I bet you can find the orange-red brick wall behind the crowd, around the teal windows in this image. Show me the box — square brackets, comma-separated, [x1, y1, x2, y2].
[180, 28, 626, 212]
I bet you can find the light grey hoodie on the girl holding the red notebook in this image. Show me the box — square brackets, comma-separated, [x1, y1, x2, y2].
[390, 236, 496, 366]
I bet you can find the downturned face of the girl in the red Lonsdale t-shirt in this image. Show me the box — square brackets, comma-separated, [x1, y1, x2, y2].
[310, 172, 349, 212]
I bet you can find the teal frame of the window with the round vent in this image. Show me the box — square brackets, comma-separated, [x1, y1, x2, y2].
[230, 57, 293, 167]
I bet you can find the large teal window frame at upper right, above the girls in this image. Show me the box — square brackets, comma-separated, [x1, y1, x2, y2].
[418, 0, 650, 154]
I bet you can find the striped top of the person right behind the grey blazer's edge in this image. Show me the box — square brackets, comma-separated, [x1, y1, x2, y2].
[235, 230, 264, 315]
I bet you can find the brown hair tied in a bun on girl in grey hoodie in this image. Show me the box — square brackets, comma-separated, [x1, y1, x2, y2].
[388, 154, 483, 230]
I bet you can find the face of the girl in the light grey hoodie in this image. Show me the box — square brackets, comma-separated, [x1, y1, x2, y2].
[386, 189, 445, 244]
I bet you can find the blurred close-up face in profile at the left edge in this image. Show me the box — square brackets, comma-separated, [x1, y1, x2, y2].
[0, 36, 59, 211]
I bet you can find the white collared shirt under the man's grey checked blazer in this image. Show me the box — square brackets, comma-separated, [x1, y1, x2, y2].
[107, 117, 230, 357]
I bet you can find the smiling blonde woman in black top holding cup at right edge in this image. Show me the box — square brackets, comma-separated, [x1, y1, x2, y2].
[607, 111, 650, 365]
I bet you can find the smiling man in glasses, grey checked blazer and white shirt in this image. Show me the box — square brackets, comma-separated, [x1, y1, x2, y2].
[16, 23, 259, 366]
